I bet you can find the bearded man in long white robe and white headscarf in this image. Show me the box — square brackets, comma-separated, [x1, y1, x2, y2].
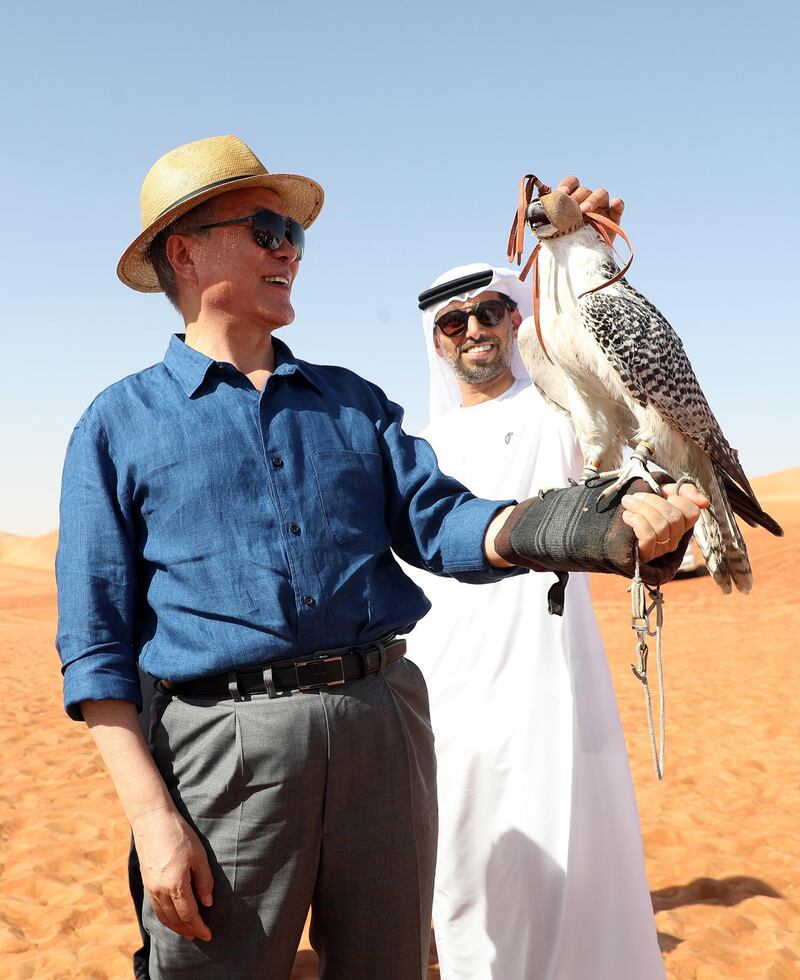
[411, 247, 664, 980]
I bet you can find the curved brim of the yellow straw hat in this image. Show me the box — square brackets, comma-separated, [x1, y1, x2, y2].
[117, 174, 325, 293]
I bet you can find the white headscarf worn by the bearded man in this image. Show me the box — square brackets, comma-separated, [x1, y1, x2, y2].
[422, 262, 533, 423]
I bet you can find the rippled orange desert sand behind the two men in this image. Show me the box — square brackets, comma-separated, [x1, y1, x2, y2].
[0, 469, 800, 980]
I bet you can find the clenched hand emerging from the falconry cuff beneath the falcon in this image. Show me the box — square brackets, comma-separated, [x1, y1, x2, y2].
[622, 483, 709, 562]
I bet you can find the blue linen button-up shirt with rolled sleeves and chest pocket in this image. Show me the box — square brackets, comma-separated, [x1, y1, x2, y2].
[56, 336, 520, 719]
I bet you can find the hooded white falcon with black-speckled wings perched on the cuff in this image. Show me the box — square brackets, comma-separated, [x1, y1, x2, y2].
[509, 174, 783, 593]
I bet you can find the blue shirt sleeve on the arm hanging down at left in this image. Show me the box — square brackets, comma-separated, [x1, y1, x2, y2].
[56, 409, 142, 720]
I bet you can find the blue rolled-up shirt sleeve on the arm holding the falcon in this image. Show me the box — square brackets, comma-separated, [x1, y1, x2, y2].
[381, 400, 525, 584]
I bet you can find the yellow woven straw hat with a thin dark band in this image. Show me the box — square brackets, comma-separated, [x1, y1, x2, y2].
[117, 136, 325, 293]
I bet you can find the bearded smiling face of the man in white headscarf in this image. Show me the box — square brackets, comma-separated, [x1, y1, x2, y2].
[433, 290, 520, 384]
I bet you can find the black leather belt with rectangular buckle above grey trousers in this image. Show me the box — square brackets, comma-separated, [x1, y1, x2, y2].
[164, 636, 406, 699]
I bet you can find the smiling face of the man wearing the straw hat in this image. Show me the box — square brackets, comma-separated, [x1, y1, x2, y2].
[180, 187, 299, 330]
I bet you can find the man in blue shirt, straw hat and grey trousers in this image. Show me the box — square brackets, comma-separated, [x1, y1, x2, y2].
[57, 136, 703, 980]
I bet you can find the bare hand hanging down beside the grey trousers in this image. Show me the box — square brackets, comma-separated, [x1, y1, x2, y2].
[132, 807, 214, 942]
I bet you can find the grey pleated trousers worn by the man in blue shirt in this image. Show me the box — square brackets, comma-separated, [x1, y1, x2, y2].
[144, 659, 437, 980]
